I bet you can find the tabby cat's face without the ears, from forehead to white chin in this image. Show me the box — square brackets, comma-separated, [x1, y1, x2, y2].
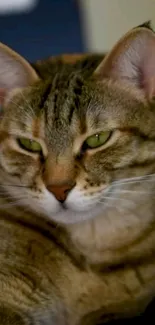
[0, 77, 155, 223]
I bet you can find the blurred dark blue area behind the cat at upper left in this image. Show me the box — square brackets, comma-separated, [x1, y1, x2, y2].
[0, 0, 84, 61]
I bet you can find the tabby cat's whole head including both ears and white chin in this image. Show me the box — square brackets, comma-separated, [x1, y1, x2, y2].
[0, 27, 155, 224]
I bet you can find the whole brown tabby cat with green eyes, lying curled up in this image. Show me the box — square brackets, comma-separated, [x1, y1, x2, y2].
[0, 21, 155, 325]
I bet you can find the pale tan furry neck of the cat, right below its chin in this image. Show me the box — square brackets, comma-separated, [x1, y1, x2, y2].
[67, 195, 155, 267]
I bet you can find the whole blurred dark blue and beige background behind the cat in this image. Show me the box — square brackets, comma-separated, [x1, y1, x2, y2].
[0, 0, 155, 61]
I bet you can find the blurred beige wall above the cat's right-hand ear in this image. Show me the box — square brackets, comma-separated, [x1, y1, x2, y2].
[79, 0, 155, 52]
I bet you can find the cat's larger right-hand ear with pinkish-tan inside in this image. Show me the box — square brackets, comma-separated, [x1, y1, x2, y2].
[95, 27, 155, 99]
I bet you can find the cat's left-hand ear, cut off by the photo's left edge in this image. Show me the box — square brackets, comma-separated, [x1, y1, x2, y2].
[0, 43, 39, 104]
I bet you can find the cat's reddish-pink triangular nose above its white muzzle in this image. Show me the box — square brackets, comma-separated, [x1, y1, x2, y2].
[47, 184, 74, 203]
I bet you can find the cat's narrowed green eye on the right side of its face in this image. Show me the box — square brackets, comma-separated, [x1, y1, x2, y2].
[84, 131, 111, 149]
